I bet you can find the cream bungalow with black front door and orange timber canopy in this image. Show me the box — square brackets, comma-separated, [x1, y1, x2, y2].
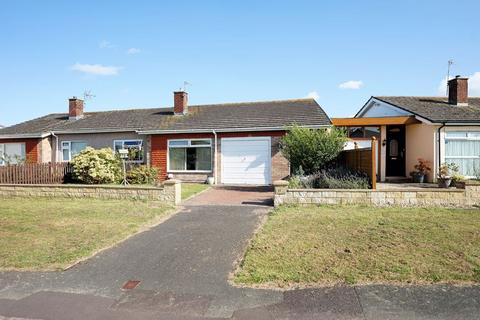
[332, 76, 480, 182]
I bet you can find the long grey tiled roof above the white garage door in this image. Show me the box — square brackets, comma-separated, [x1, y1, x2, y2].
[0, 99, 331, 136]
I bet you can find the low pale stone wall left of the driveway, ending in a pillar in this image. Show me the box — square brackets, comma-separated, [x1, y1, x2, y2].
[0, 180, 181, 205]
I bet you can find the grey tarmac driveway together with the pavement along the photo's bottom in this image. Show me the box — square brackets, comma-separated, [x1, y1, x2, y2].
[0, 190, 480, 319]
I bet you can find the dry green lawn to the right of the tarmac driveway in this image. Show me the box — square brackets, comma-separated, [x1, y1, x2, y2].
[234, 206, 480, 287]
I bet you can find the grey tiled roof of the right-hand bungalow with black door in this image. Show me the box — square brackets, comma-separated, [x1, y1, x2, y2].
[374, 97, 480, 123]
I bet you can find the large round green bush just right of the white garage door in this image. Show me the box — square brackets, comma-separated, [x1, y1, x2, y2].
[280, 125, 347, 174]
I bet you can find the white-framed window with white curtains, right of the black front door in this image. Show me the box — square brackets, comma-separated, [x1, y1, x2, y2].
[445, 131, 480, 176]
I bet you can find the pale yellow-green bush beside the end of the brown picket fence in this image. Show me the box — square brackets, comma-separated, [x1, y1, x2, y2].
[71, 147, 122, 184]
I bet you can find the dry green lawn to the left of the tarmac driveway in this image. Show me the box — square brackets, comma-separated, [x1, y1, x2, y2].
[0, 198, 173, 270]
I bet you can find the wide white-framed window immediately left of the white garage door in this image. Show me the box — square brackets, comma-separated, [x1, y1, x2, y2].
[168, 139, 212, 172]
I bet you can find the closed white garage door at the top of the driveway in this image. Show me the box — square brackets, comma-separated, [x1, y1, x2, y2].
[221, 137, 271, 185]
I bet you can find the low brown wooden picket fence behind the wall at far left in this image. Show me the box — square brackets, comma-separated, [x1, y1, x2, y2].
[0, 163, 73, 184]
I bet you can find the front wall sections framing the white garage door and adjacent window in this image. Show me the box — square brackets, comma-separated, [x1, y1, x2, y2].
[151, 131, 290, 181]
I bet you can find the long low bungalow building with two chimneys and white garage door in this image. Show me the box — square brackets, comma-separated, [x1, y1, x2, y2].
[0, 91, 331, 185]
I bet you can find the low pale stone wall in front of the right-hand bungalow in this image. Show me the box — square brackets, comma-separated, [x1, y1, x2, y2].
[274, 181, 480, 207]
